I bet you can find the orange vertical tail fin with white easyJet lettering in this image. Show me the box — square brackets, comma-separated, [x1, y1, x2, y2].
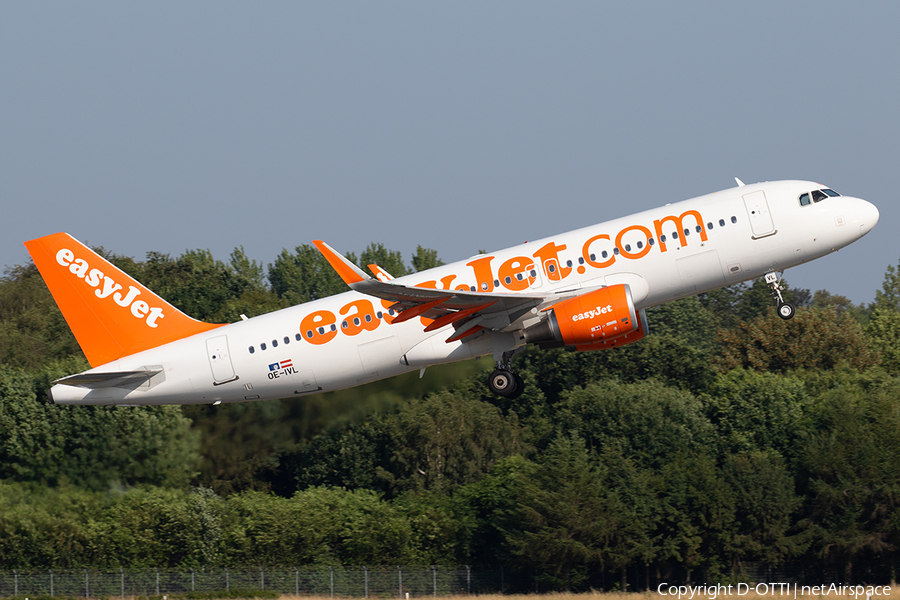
[25, 233, 221, 367]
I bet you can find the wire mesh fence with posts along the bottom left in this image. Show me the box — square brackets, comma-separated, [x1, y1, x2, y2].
[0, 566, 504, 598]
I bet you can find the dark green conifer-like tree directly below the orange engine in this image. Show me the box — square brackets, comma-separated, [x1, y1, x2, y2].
[507, 436, 654, 590]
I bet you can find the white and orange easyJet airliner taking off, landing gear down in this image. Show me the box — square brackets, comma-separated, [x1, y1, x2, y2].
[25, 180, 878, 405]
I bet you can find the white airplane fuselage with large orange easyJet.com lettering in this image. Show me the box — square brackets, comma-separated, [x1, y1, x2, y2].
[52, 181, 878, 404]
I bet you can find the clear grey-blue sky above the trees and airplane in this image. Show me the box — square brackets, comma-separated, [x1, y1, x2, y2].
[0, 1, 900, 302]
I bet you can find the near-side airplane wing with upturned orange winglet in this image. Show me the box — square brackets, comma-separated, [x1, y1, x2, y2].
[313, 240, 555, 342]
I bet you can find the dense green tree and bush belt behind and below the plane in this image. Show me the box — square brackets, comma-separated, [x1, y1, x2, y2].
[0, 244, 900, 590]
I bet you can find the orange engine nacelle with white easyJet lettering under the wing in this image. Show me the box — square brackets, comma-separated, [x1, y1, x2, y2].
[525, 283, 647, 350]
